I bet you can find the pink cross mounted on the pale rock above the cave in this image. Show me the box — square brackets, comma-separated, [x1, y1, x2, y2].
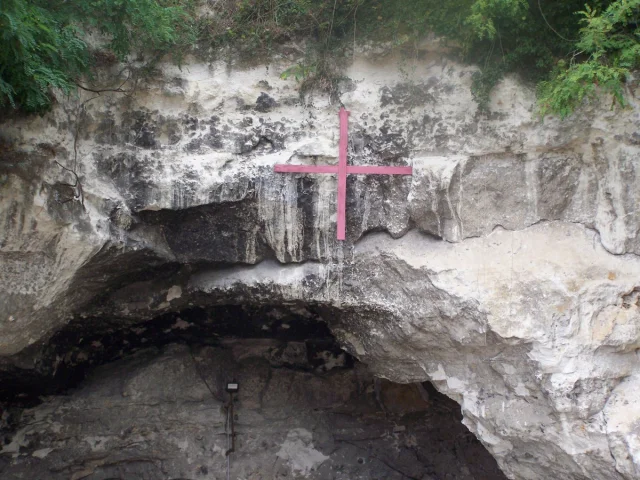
[275, 108, 413, 240]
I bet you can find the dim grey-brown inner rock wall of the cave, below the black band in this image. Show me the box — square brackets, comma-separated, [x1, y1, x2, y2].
[0, 340, 504, 480]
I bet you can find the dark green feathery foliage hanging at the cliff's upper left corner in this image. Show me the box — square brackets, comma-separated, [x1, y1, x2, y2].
[0, 0, 191, 112]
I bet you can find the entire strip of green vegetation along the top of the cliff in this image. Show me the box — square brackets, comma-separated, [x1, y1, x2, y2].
[0, 0, 640, 117]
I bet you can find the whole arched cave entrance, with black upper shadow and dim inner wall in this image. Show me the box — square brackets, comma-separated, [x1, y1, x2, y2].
[0, 305, 505, 480]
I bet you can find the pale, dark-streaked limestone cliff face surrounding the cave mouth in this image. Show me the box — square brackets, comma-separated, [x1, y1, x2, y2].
[0, 42, 640, 480]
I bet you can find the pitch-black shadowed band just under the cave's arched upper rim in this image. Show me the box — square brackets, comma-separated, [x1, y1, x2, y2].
[0, 304, 354, 406]
